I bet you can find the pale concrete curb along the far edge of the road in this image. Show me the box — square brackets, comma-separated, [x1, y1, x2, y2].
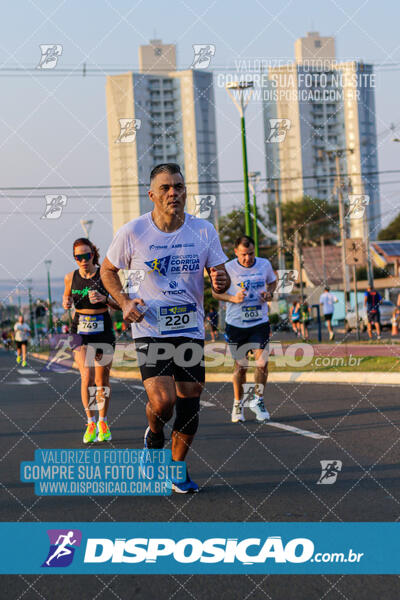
[30, 352, 400, 386]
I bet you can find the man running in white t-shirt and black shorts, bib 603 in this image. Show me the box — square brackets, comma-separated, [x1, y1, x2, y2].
[213, 235, 277, 423]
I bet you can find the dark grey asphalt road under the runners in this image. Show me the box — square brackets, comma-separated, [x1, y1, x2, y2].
[0, 350, 400, 600]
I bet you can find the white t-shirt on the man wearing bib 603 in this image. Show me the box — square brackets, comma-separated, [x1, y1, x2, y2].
[225, 257, 276, 327]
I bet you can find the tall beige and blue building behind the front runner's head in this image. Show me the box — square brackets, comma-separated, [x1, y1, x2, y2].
[106, 40, 219, 232]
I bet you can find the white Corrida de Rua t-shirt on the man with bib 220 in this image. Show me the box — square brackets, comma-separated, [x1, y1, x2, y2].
[107, 212, 228, 339]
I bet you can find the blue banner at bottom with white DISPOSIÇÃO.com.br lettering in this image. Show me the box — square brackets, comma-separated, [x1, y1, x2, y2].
[0, 522, 400, 575]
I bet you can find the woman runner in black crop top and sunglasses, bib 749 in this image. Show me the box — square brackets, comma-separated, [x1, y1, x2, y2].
[63, 238, 119, 444]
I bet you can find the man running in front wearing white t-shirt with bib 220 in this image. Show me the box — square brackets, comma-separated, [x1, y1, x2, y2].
[101, 163, 230, 493]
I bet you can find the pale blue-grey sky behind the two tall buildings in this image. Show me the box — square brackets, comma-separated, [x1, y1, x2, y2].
[0, 0, 400, 301]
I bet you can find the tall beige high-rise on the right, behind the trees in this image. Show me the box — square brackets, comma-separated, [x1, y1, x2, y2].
[264, 32, 380, 237]
